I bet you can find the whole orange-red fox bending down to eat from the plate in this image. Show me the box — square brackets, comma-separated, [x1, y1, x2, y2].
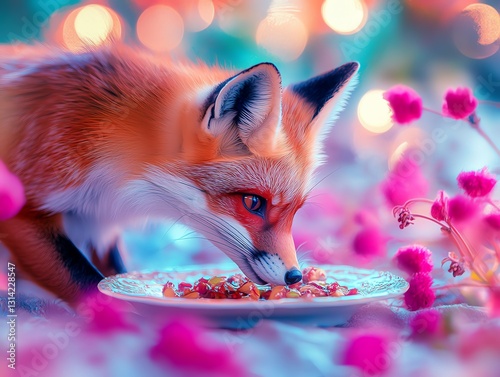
[0, 46, 358, 302]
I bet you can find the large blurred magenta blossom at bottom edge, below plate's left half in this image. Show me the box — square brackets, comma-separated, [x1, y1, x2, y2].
[149, 318, 248, 376]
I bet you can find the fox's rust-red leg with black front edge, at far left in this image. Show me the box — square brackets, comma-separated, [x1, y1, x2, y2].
[0, 213, 103, 303]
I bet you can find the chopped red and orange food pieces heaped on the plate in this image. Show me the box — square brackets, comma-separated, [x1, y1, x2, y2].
[163, 267, 358, 300]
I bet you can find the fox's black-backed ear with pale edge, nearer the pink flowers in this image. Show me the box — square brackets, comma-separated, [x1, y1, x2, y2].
[289, 62, 359, 140]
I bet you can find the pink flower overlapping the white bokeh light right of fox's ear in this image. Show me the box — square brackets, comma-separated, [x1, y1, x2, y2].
[384, 85, 422, 124]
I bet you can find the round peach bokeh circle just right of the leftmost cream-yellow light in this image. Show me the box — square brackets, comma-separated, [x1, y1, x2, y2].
[137, 5, 184, 52]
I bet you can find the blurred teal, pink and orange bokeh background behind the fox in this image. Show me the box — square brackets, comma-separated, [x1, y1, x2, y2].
[0, 0, 500, 269]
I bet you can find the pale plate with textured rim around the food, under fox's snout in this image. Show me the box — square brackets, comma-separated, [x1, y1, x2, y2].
[98, 265, 409, 310]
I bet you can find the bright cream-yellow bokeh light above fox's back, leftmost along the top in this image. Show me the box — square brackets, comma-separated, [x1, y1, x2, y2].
[62, 4, 122, 51]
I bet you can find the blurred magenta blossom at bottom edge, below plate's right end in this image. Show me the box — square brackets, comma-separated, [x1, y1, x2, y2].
[342, 332, 393, 376]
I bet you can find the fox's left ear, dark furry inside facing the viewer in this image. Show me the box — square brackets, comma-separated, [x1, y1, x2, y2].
[203, 63, 281, 155]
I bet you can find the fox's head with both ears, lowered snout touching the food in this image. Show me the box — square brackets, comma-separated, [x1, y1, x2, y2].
[139, 62, 358, 285]
